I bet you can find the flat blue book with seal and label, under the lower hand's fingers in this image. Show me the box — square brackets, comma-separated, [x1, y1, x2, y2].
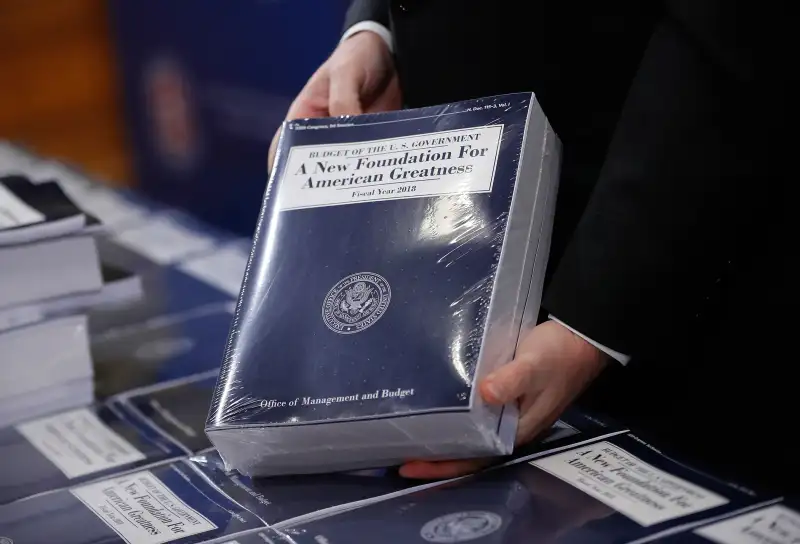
[282, 435, 776, 544]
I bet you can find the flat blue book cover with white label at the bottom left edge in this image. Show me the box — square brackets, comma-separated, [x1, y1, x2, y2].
[0, 462, 263, 544]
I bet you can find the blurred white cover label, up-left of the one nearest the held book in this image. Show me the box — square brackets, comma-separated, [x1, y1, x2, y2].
[114, 216, 214, 264]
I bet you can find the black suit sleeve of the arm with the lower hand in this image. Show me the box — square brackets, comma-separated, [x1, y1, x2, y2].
[543, 0, 791, 357]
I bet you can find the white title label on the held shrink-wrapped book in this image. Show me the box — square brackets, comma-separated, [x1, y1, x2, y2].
[278, 125, 503, 210]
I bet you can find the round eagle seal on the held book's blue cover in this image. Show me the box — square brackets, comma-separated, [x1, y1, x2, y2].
[322, 272, 392, 334]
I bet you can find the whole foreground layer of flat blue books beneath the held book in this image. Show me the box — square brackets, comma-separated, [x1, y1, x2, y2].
[0, 400, 800, 544]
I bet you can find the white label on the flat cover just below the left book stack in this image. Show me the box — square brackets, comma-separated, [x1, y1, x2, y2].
[16, 409, 145, 478]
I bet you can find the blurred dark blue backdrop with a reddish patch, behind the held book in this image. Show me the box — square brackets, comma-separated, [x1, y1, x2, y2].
[111, 0, 348, 235]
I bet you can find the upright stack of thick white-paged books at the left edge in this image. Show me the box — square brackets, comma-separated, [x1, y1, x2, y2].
[0, 175, 140, 430]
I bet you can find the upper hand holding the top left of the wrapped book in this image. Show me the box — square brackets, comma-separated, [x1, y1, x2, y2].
[269, 31, 402, 171]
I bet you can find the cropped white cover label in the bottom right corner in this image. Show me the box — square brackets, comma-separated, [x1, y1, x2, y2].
[695, 505, 800, 544]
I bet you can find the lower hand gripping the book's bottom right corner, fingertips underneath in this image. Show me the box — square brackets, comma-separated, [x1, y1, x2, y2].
[400, 321, 608, 479]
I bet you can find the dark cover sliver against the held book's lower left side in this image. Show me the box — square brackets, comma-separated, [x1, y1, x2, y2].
[113, 369, 218, 453]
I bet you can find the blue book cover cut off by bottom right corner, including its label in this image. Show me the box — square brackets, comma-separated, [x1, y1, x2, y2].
[648, 499, 800, 544]
